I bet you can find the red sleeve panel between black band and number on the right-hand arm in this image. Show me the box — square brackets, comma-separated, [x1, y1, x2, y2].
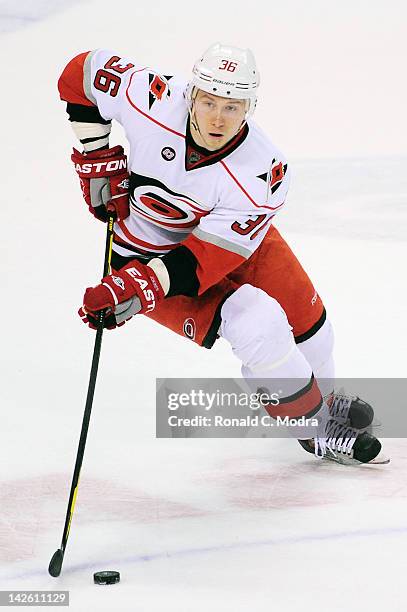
[182, 234, 246, 295]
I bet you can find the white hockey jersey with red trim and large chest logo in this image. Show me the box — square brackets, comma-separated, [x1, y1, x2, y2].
[59, 49, 289, 293]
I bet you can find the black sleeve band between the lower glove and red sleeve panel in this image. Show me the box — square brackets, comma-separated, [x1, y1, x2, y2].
[161, 245, 199, 297]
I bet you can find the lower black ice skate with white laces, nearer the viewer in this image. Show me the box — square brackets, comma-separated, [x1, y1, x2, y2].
[298, 419, 390, 465]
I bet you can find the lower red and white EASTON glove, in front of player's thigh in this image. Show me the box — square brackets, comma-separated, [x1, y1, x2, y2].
[78, 261, 164, 329]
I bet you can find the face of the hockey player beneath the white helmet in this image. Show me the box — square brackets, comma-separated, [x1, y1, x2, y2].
[191, 90, 246, 151]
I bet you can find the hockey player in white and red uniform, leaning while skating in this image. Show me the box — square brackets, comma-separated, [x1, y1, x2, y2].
[58, 43, 381, 463]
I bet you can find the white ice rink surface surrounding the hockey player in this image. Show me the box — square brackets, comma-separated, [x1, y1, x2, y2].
[0, 0, 407, 612]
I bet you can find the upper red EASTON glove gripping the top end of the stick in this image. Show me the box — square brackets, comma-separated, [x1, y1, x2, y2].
[71, 145, 129, 221]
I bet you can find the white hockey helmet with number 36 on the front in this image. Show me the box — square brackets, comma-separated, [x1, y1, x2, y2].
[186, 43, 260, 119]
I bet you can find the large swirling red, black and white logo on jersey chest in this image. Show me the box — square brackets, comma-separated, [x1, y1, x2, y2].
[130, 172, 209, 232]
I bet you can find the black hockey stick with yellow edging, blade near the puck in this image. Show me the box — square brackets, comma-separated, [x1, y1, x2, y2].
[48, 212, 114, 578]
